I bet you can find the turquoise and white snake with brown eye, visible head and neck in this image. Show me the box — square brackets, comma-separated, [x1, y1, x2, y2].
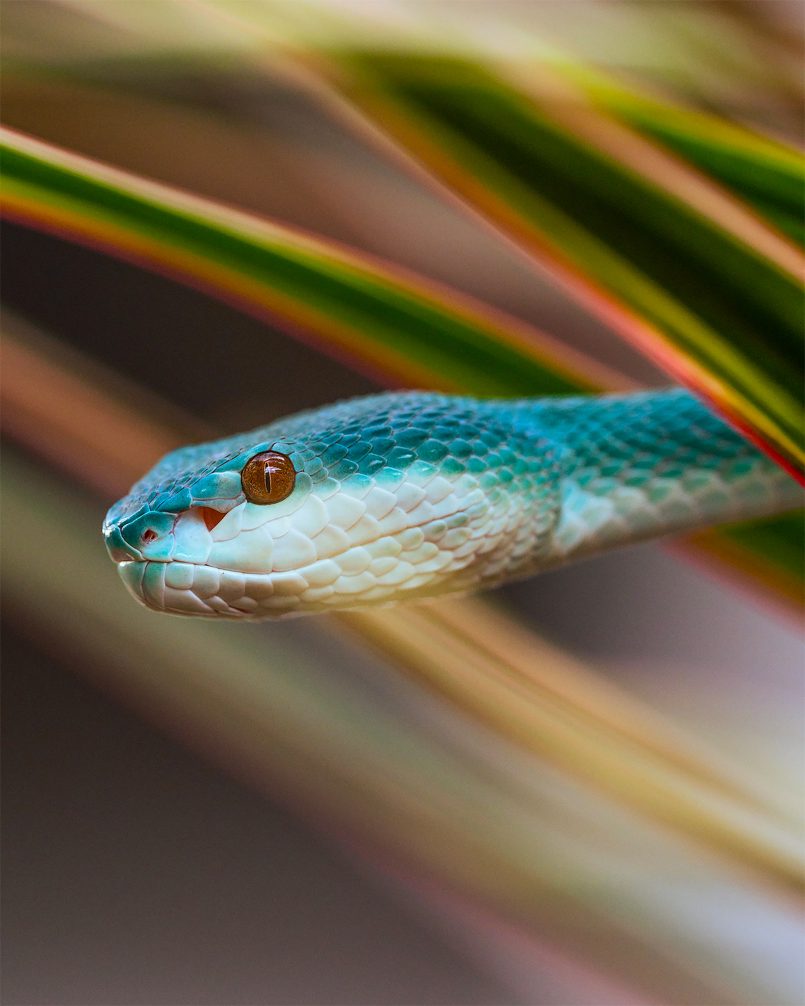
[103, 387, 802, 619]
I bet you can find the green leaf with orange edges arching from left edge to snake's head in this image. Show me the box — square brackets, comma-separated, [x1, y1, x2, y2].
[1, 123, 617, 394]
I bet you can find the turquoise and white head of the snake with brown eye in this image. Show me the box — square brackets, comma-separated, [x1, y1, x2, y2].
[104, 392, 555, 619]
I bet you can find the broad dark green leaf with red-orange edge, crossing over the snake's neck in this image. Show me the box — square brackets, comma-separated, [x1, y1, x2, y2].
[309, 50, 805, 475]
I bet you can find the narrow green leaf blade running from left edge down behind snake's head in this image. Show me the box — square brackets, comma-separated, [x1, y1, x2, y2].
[3, 133, 593, 395]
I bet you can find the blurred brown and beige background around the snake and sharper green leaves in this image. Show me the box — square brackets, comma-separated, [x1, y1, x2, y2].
[2, 0, 805, 1006]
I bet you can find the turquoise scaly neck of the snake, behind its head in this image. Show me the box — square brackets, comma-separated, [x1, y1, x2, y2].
[509, 388, 802, 568]
